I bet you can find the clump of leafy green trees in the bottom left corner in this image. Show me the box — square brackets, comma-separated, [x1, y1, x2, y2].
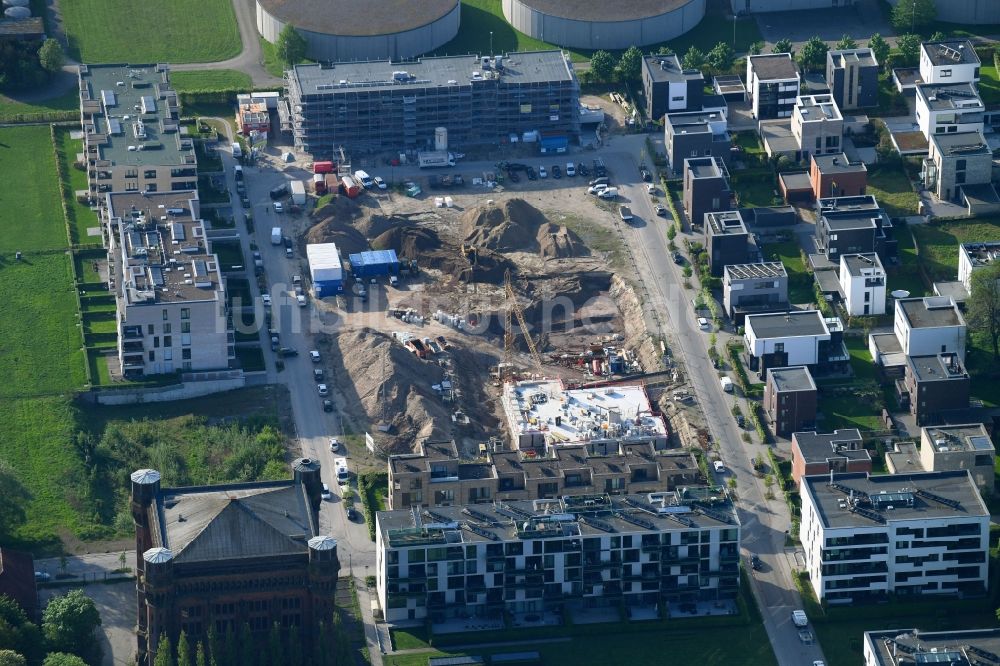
[0, 590, 102, 666]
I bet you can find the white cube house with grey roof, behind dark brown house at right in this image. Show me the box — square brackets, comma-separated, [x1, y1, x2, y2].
[893, 296, 966, 361]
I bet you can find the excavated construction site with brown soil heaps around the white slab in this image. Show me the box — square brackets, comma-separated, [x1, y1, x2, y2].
[278, 182, 708, 457]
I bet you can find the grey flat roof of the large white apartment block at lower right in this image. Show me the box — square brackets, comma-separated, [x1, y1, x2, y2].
[801, 469, 990, 529]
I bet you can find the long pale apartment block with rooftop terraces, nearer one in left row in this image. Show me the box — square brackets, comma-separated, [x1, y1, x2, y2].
[104, 192, 230, 378]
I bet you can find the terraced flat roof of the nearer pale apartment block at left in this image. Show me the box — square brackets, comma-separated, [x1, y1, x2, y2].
[106, 191, 223, 306]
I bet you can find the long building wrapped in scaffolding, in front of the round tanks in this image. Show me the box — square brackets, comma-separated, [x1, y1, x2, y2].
[279, 51, 580, 158]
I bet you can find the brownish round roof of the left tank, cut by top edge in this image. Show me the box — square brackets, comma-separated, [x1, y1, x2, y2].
[257, 0, 459, 37]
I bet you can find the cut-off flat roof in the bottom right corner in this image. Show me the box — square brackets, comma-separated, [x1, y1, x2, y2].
[865, 629, 1000, 666]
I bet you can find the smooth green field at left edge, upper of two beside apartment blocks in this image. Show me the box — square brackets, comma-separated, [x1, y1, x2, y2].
[0, 125, 66, 252]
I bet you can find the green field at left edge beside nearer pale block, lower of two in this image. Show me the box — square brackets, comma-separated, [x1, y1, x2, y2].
[0, 253, 86, 402]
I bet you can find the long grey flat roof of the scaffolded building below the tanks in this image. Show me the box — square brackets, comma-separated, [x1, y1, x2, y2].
[289, 51, 575, 95]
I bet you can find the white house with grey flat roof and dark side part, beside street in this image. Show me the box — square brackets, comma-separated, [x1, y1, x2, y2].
[743, 310, 850, 377]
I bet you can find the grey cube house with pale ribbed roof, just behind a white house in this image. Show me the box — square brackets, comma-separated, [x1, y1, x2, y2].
[722, 261, 789, 326]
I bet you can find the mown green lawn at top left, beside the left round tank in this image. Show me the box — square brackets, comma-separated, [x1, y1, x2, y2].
[59, 0, 242, 63]
